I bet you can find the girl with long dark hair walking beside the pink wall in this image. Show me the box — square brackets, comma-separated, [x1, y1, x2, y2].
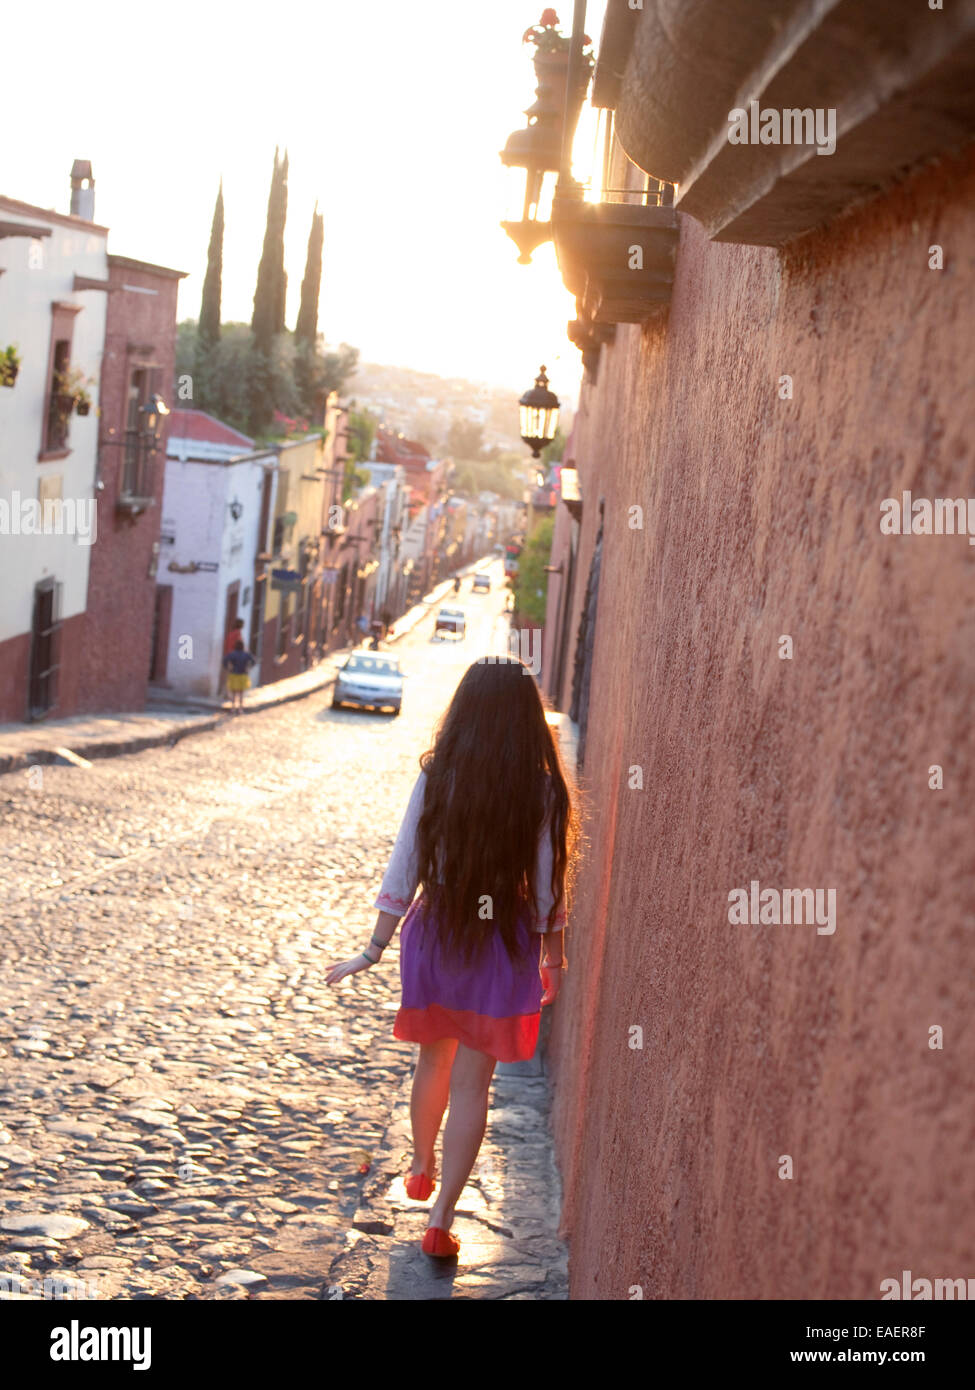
[325, 657, 576, 1258]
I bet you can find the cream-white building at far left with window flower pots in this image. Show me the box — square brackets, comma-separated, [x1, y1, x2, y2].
[0, 189, 108, 720]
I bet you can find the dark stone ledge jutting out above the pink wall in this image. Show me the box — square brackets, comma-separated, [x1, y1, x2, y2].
[604, 0, 975, 246]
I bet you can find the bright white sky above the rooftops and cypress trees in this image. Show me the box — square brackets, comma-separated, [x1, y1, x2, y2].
[0, 0, 605, 396]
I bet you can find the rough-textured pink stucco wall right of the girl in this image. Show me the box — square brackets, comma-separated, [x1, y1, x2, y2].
[549, 143, 975, 1298]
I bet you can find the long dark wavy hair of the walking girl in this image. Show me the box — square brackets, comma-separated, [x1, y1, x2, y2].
[417, 657, 576, 960]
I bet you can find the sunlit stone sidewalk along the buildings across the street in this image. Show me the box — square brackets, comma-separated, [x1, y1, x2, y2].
[0, 562, 484, 776]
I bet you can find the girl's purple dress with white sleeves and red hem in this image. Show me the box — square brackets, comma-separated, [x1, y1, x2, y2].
[376, 771, 565, 1062]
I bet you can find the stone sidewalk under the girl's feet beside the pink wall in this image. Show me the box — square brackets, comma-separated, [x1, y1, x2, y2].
[320, 1011, 569, 1302]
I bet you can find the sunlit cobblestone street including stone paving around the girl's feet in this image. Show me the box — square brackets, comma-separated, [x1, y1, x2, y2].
[0, 569, 565, 1300]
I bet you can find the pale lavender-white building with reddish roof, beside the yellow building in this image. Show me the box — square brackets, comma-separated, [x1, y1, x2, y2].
[159, 410, 278, 699]
